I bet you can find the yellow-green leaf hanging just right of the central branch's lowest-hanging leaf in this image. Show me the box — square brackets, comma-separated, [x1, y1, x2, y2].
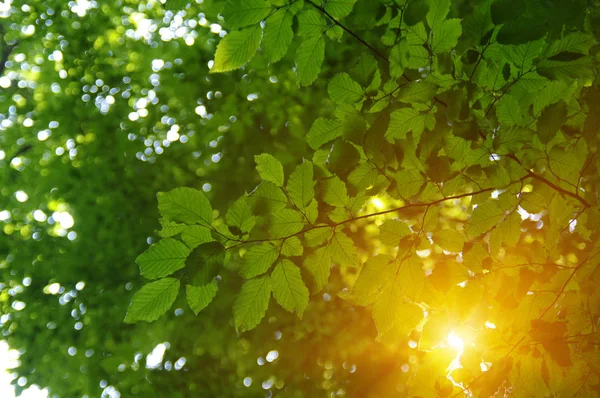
[271, 260, 308, 319]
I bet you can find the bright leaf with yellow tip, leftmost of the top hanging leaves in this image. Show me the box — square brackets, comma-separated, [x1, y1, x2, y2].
[210, 25, 262, 73]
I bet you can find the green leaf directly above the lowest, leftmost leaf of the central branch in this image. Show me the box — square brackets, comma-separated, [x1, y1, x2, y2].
[135, 239, 190, 279]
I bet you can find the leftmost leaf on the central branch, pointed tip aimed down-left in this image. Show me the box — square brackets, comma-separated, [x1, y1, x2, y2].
[124, 278, 179, 323]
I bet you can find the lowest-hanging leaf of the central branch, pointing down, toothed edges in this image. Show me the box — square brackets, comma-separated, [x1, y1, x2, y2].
[233, 276, 271, 332]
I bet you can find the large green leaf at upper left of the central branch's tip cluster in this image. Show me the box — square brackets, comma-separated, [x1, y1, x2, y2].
[156, 187, 212, 226]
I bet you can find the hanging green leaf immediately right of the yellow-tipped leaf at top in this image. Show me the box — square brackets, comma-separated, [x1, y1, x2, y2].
[263, 7, 294, 63]
